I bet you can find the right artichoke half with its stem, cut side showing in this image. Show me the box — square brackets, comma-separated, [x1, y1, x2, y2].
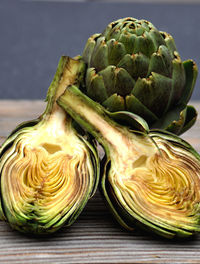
[57, 85, 200, 238]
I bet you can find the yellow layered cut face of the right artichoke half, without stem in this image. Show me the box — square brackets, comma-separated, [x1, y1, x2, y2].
[109, 134, 200, 231]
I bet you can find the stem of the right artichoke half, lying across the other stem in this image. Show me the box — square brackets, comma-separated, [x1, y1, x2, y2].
[57, 86, 151, 157]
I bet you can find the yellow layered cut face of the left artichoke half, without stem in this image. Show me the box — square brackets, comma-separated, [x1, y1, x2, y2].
[1, 109, 93, 231]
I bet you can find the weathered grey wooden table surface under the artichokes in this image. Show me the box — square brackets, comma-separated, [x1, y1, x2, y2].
[0, 101, 200, 264]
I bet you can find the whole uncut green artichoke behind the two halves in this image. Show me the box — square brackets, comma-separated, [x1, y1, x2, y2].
[82, 17, 197, 134]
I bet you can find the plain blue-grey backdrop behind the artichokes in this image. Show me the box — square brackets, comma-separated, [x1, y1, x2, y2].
[0, 0, 200, 99]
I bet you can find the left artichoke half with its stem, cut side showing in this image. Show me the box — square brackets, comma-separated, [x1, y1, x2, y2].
[0, 57, 99, 235]
